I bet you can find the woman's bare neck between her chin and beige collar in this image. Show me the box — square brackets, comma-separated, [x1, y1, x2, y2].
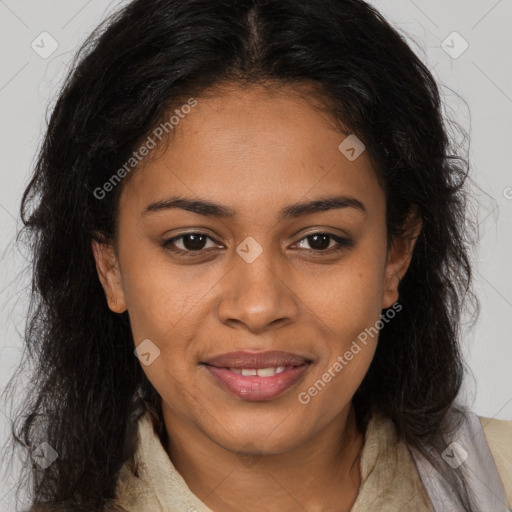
[163, 404, 364, 512]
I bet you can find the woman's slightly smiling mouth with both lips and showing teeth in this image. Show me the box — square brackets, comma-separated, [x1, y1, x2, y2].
[201, 351, 313, 401]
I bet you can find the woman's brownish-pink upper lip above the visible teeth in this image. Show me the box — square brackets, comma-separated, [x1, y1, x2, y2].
[203, 350, 311, 369]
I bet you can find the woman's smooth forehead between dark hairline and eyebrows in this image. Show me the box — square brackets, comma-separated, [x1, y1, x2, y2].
[121, 86, 382, 221]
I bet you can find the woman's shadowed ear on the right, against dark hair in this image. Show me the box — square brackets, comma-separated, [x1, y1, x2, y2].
[382, 208, 422, 309]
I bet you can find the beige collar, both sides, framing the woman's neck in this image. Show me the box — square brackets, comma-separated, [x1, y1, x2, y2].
[108, 414, 434, 512]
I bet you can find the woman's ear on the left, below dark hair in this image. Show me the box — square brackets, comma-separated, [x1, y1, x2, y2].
[91, 240, 126, 313]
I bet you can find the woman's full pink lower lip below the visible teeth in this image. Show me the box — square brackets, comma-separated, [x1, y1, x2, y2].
[203, 363, 309, 401]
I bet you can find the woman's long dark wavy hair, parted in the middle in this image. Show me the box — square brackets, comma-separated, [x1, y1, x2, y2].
[0, 0, 479, 512]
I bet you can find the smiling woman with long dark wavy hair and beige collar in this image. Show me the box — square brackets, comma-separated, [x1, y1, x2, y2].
[5, 0, 512, 512]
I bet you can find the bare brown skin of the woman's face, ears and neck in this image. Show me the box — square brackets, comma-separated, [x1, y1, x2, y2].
[92, 82, 420, 512]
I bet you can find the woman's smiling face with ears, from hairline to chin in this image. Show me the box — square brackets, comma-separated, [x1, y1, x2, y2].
[93, 86, 418, 453]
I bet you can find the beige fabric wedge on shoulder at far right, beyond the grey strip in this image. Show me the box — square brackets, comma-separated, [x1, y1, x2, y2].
[479, 416, 512, 507]
